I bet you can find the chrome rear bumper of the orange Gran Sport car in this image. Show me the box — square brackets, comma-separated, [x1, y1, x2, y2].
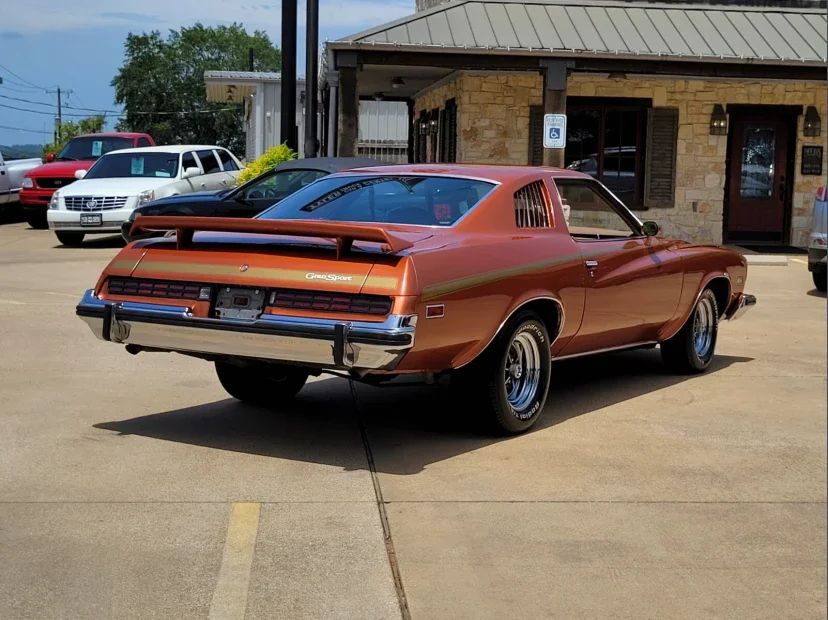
[76, 290, 417, 370]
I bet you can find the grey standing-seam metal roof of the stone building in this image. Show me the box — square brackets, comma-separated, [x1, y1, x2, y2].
[330, 0, 828, 65]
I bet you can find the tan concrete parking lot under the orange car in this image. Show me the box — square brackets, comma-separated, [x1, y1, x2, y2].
[0, 222, 826, 620]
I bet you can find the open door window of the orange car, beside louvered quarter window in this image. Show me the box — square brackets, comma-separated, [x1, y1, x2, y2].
[555, 179, 641, 239]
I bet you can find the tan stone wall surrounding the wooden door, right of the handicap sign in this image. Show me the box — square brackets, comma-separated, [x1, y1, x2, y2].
[567, 74, 828, 246]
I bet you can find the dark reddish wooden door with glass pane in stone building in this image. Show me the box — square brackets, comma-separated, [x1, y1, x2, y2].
[727, 117, 789, 243]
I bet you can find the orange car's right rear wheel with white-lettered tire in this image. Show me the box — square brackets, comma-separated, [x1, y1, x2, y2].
[456, 311, 552, 435]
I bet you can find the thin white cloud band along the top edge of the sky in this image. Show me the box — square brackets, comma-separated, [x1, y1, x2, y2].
[3, 0, 414, 35]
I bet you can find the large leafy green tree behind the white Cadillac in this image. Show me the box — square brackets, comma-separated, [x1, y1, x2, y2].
[112, 24, 282, 154]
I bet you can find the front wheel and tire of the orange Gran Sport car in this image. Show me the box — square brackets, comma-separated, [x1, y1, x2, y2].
[661, 289, 719, 374]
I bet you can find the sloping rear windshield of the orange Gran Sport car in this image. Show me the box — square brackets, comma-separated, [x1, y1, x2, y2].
[258, 175, 495, 226]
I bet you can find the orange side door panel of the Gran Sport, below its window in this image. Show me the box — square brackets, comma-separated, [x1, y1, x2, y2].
[561, 237, 682, 356]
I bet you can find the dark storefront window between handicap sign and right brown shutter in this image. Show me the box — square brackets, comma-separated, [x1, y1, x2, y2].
[564, 98, 646, 206]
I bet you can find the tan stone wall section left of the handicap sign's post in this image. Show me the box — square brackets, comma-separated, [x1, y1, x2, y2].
[414, 72, 543, 165]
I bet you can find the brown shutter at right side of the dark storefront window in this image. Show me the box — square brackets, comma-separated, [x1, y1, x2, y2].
[644, 108, 678, 208]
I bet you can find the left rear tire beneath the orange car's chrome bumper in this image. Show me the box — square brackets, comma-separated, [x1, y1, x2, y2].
[216, 362, 308, 408]
